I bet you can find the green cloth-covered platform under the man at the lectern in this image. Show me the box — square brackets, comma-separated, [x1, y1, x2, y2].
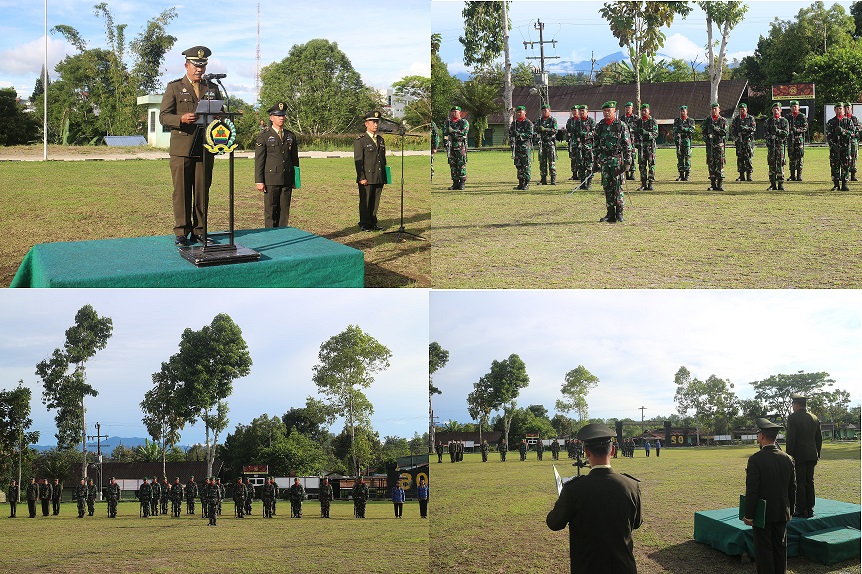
[10, 227, 365, 288]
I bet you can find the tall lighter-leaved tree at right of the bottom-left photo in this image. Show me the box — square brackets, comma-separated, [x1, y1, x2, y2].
[312, 325, 392, 480]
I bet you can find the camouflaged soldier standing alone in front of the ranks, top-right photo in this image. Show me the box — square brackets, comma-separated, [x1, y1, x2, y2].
[595, 100, 634, 223]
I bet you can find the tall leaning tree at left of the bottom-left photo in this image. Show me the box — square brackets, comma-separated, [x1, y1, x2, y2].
[36, 305, 114, 478]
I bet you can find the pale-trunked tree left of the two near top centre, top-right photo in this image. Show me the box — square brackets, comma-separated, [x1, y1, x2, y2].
[599, 0, 691, 109]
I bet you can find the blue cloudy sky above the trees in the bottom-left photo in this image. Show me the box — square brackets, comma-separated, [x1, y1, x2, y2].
[0, 289, 428, 444]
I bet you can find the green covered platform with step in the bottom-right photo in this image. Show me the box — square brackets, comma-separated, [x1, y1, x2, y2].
[694, 498, 862, 561]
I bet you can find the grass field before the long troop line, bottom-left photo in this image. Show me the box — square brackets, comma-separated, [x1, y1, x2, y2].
[0, 500, 429, 574]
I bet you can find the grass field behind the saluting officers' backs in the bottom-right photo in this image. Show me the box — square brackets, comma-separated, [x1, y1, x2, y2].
[429, 444, 860, 574]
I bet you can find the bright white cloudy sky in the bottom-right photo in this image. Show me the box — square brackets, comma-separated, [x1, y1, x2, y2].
[431, 290, 862, 428]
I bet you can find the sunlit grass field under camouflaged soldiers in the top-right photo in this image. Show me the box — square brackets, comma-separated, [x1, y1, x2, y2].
[429, 147, 862, 289]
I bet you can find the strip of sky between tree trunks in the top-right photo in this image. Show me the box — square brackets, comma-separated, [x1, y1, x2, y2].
[431, 0, 852, 78]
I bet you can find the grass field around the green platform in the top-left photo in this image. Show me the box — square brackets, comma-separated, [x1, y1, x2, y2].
[0, 152, 431, 287]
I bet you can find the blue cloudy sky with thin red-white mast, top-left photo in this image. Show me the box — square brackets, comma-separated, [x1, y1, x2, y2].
[0, 0, 431, 103]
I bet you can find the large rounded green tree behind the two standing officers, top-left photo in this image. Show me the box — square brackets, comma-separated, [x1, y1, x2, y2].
[260, 38, 375, 135]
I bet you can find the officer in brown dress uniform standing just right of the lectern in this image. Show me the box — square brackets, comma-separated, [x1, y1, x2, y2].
[254, 102, 299, 227]
